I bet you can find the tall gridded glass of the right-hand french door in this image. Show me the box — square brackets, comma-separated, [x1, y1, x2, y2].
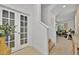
[20, 15, 27, 45]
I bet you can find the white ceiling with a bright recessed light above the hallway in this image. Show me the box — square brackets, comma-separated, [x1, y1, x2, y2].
[43, 4, 78, 22]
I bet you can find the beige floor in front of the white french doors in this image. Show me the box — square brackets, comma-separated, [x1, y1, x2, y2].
[12, 46, 41, 55]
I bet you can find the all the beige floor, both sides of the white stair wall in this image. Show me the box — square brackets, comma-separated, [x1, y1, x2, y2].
[12, 37, 73, 55]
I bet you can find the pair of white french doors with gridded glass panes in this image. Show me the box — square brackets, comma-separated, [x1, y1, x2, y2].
[0, 7, 28, 52]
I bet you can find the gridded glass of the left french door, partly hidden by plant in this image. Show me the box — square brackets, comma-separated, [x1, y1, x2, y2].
[2, 10, 15, 49]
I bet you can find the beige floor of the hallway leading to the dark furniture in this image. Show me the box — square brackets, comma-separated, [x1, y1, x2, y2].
[50, 37, 73, 55]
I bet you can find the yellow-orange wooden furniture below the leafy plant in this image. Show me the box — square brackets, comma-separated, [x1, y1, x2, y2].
[0, 37, 11, 55]
